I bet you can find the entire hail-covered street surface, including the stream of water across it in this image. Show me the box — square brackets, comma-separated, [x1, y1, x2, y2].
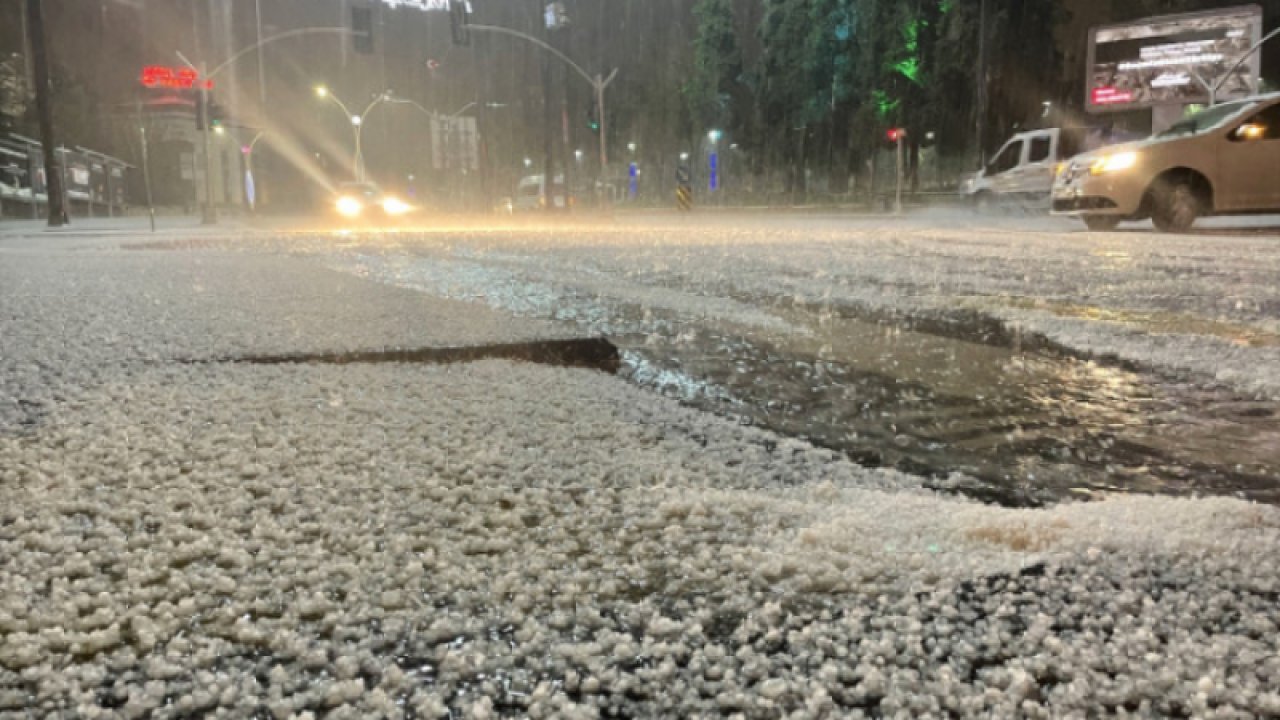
[0, 217, 1280, 719]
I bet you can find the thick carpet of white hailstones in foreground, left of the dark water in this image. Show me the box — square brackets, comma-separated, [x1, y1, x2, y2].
[0, 234, 1280, 720]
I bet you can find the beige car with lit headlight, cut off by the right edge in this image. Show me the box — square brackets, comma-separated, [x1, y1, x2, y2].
[1052, 94, 1280, 232]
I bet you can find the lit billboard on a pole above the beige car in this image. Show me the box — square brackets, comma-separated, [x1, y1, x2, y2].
[1084, 5, 1262, 113]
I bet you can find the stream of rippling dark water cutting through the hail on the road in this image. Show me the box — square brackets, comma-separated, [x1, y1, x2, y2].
[338, 256, 1280, 505]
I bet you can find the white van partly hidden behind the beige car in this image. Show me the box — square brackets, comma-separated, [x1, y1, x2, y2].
[960, 128, 1125, 209]
